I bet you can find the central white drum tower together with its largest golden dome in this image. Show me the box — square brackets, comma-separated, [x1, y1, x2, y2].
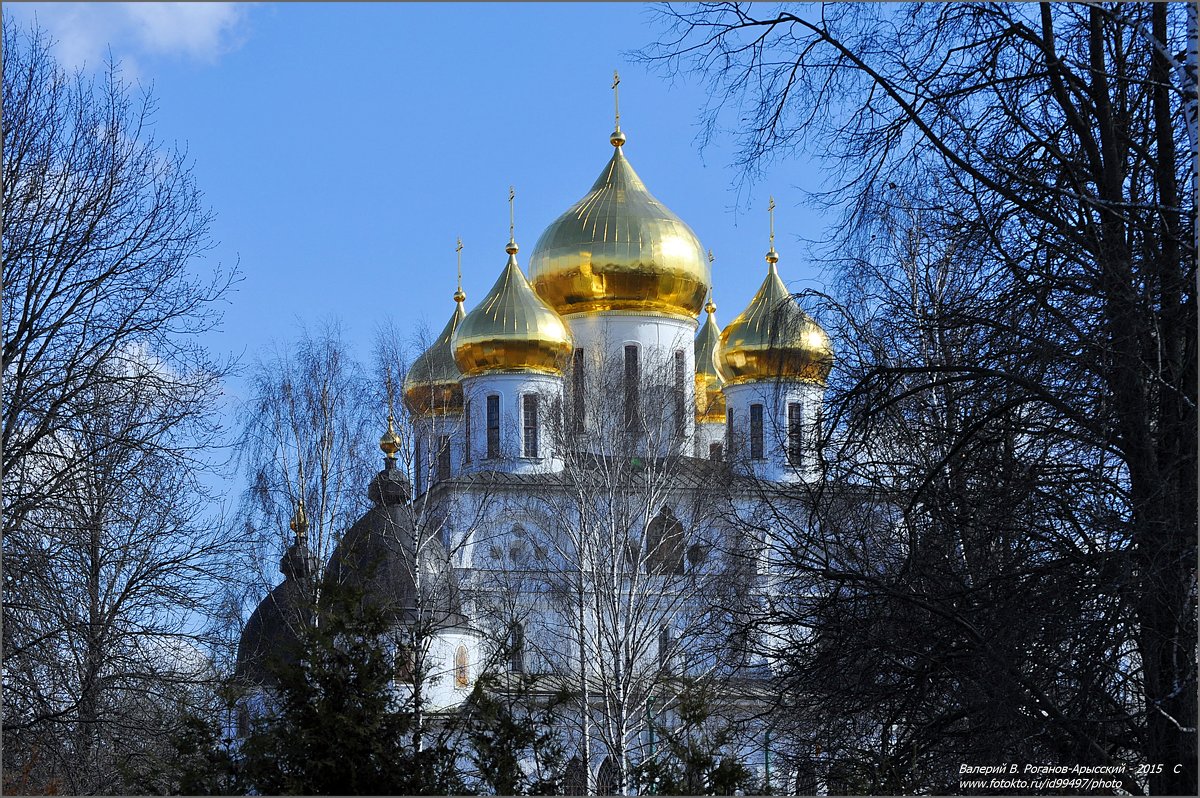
[529, 73, 712, 455]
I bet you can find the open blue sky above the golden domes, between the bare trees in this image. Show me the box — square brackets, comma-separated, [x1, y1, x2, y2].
[5, 2, 822, 420]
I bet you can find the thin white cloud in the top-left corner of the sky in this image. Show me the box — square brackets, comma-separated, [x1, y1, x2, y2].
[5, 2, 247, 76]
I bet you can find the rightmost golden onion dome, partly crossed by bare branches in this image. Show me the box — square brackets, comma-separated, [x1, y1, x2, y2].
[719, 247, 833, 385]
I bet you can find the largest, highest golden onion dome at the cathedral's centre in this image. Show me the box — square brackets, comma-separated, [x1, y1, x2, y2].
[529, 130, 710, 319]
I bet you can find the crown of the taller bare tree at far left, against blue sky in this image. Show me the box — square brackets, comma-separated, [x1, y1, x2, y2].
[0, 22, 234, 542]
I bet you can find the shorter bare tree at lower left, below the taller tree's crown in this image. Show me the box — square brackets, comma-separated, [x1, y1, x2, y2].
[5, 365, 233, 793]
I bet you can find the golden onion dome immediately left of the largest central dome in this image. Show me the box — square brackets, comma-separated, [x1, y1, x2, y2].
[454, 241, 571, 377]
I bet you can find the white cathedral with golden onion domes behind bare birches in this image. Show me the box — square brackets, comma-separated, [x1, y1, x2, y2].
[239, 104, 833, 792]
